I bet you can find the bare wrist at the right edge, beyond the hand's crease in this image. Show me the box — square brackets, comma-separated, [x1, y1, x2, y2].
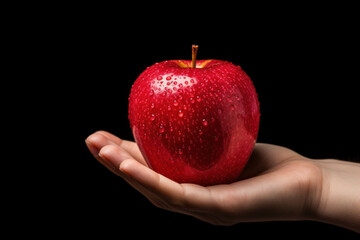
[311, 159, 360, 232]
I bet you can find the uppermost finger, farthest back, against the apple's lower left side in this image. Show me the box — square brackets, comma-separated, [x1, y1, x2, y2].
[97, 131, 147, 166]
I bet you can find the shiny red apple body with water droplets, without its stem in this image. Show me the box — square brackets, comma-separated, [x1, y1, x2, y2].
[129, 60, 260, 186]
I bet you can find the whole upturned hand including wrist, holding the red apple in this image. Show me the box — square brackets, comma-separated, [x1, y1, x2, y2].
[86, 131, 360, 232]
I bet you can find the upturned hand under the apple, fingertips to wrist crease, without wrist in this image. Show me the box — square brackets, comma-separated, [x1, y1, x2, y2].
[87, 131, 321, 225]
